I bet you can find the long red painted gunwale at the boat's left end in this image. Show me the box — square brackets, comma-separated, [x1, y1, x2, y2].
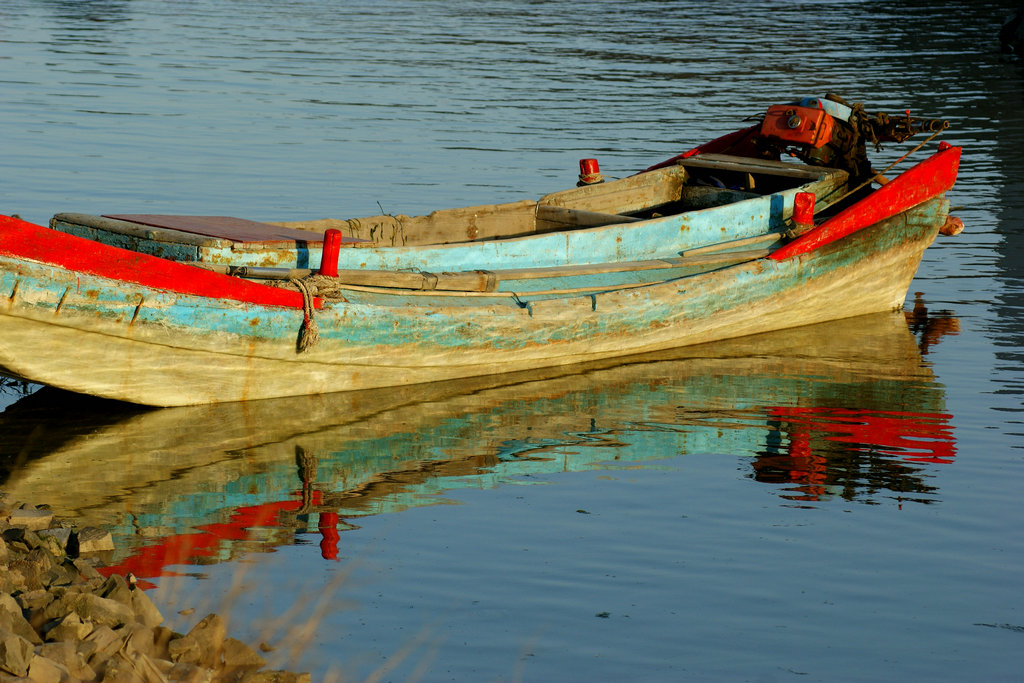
[0, 216, 307, 308]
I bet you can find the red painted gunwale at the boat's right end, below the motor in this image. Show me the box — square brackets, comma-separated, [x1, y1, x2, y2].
[768, 142, 961, 261]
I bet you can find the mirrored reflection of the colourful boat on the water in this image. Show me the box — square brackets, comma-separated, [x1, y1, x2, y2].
[0, 305, 956, 579]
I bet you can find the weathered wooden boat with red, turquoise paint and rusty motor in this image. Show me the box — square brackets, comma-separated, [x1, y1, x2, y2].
[0, 99, 962, 405]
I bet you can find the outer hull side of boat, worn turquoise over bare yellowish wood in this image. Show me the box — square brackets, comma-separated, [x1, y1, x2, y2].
[0, 199, 948, 405]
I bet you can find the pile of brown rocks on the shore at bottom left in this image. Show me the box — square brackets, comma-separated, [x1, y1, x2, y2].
[0, 492, 310, 683]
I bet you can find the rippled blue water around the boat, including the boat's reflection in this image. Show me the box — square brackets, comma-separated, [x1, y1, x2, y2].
[0, 0, 1024, 681]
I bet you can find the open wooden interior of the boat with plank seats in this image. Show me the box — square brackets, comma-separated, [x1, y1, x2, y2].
[50, 155, 846, 252]
